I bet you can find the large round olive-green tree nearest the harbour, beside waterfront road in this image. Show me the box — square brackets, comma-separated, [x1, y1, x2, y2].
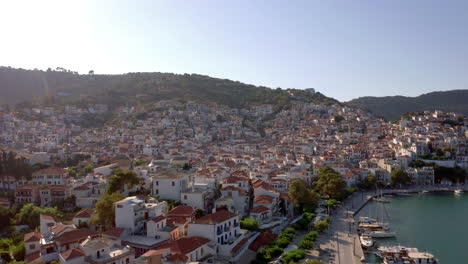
[315, 166, 346, 198]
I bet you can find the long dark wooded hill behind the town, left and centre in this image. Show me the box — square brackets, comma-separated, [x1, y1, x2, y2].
[0, 67, 339, 110]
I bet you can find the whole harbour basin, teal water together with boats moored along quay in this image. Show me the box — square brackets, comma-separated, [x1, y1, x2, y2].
[351, 187, 468, 264]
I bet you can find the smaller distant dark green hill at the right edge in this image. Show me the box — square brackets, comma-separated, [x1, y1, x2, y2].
[348, 90, 468, 120]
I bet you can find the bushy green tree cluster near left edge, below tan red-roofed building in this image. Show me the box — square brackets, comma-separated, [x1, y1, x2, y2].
[15, 204, 63, 229]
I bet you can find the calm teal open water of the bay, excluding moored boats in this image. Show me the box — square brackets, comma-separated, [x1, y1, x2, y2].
[359, 193, 468, 264]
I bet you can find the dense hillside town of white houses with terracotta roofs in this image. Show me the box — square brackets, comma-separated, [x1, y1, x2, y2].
[0, 99, 468, 264]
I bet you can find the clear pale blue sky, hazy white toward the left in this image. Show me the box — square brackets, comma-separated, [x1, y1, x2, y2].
[0, 0, 468, 101]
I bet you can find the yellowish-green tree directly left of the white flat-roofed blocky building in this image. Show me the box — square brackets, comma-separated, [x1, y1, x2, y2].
[91, 192, 125, 228]
